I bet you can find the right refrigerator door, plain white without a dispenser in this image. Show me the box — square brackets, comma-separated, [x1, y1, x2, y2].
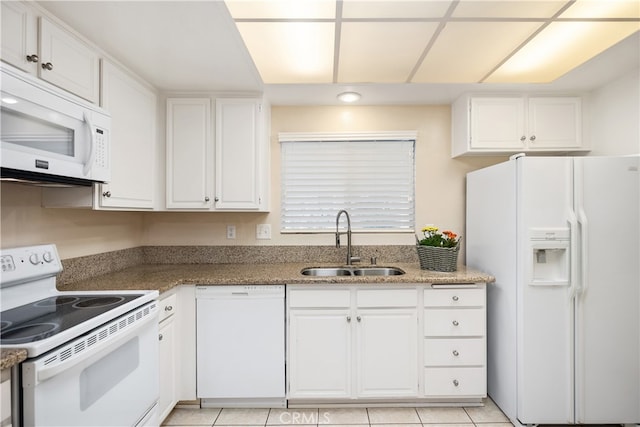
[575, 156, 640, 424]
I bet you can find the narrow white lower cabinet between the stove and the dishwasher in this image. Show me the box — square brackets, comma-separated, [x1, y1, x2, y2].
[158, 293, 178, 420]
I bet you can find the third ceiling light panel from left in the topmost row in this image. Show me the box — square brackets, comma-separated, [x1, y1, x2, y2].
[452, 0, 569, 19]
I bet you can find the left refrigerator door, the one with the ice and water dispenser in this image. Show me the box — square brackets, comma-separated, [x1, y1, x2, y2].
[517, 157, 573, 424]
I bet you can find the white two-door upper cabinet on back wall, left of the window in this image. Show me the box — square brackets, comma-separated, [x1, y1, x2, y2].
[167, 98, 269, 211]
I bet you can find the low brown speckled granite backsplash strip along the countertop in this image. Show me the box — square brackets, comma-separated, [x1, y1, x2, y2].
[58, 245, 418, 284]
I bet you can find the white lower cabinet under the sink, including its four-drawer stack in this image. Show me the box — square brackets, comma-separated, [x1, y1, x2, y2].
[287, 284, 486, 406]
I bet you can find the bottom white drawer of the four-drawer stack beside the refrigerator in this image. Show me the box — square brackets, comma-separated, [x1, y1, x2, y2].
[424, 368, 487, 397]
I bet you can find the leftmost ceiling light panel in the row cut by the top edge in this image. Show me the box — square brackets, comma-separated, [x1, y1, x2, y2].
[225, 0, 336, 19]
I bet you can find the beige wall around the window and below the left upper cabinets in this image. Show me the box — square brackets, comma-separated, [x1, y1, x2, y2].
[0, 106, 504, 258]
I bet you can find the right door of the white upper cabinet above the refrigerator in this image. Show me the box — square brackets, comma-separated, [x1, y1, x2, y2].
[528, 97, 582, 150]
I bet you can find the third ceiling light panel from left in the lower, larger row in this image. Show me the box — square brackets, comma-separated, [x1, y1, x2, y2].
[412, 22, 540, 83]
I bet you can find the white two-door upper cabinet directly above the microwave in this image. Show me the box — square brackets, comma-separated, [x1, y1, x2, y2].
[2, 1, 100, 104]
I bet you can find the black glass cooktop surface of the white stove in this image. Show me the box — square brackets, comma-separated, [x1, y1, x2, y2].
[0, 294, 143, 345]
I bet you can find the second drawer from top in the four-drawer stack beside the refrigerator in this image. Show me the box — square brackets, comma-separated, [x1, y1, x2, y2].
[424, 308, 485, 337]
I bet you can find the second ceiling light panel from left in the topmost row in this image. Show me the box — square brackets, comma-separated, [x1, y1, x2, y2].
[342, 0, 452, 19]
